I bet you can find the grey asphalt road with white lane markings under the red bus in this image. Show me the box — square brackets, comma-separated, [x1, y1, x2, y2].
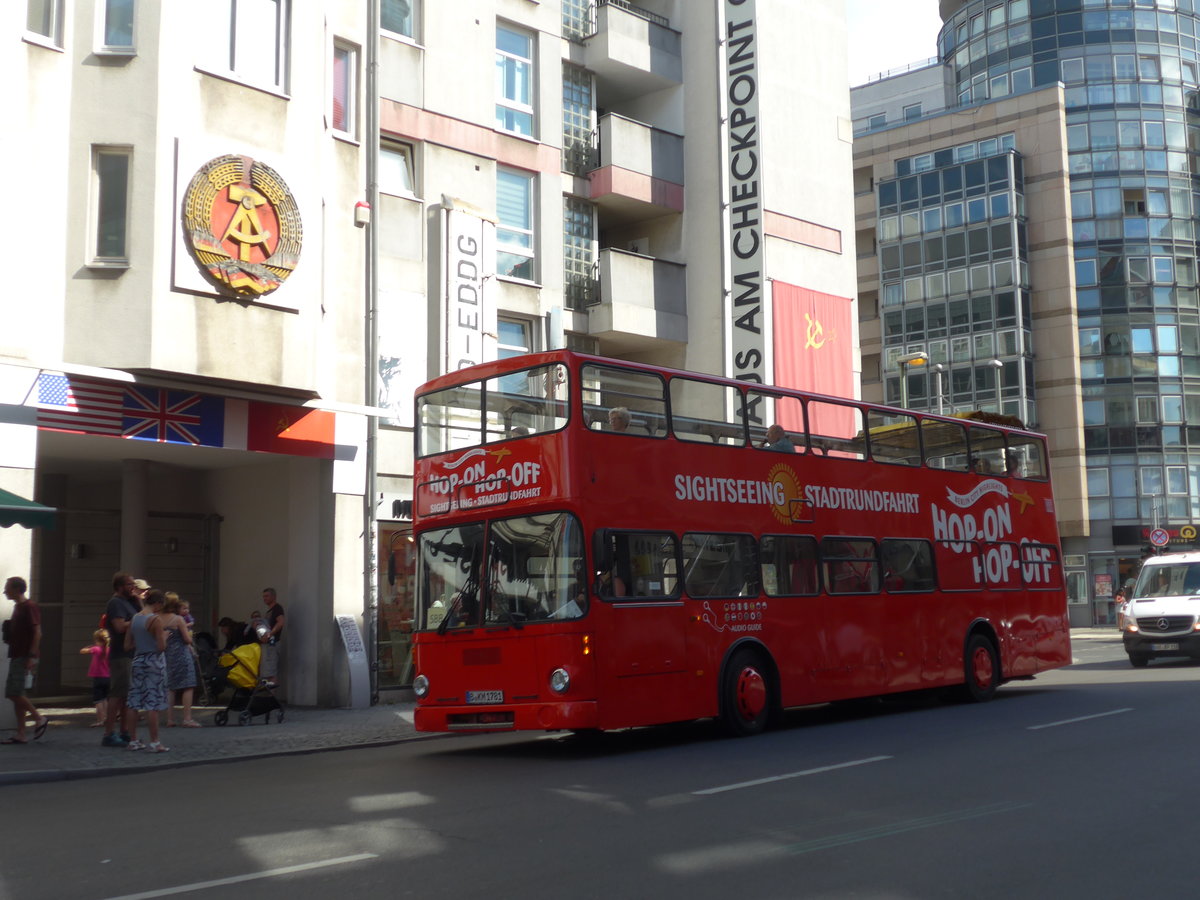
[0, 642, 1200, 900]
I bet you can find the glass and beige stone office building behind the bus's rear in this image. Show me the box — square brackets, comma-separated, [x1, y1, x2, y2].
[852, 0, 1200, 624]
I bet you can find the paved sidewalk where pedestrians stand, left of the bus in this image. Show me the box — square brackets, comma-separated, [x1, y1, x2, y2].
[0, 698, 437, 787]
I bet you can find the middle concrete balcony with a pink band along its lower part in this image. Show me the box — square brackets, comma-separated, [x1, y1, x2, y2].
[588, 113, 684, 228]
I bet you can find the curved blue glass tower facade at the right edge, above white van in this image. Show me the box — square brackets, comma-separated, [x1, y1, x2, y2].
[938, 0, 1200, 526]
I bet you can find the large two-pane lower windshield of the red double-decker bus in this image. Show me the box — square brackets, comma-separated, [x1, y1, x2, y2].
[418, 512, 588, 631]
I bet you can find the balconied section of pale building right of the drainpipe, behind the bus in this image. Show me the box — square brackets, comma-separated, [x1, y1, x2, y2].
[369, 0, 858, 685]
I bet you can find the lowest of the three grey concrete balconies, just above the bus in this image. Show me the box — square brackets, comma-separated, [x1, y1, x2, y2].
[588, 247, 688, 354]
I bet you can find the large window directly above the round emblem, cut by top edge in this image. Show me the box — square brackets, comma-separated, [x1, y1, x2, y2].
[206, 0, 290, 91]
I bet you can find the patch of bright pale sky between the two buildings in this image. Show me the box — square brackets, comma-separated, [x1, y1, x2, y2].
[846, 0, 942, 85]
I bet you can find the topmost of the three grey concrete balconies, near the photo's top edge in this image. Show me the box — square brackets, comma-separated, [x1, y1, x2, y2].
[583, 0, 683, 107]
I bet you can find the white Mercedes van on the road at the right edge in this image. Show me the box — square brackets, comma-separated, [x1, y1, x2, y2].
[1122, 552, 1200, 667]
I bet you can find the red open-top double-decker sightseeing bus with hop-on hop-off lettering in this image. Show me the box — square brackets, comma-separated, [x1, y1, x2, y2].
[413, 350, 1070, 734]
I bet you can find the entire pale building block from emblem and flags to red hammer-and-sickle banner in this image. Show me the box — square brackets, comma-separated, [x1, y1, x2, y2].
[0, 0, 859, 704]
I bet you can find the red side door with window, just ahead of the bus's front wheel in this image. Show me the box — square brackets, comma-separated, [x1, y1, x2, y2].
[594, 529, 697, 728]
